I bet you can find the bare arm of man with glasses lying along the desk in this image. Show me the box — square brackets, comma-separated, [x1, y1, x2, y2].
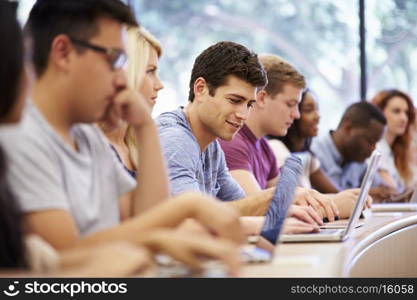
[24, 193, 243, 250]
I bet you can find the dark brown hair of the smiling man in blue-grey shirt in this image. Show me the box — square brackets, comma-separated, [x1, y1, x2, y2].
[188, 42, 268, 102]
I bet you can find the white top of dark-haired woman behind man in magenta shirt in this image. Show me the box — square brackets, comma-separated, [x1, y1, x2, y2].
[268, 139, 320, 189]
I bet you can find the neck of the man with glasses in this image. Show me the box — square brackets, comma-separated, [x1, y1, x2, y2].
[31, 74, 75, 147]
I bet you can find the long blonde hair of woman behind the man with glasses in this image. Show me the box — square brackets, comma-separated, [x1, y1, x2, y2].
[125, 27, 162, 170]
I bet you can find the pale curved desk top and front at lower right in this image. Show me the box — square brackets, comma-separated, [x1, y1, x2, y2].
[242, 212, 417, 277]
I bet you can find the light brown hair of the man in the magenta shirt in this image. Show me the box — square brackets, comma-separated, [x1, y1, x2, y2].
[259, 54, 307, 96]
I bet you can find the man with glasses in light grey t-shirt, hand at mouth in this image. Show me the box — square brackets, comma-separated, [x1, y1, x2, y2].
[0, 0, 242, 265]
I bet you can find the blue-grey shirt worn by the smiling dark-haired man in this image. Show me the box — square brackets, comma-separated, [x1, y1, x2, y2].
[156, 109, 245, 201]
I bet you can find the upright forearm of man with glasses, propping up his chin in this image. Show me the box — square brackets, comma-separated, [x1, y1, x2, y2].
[132, 121, 169, 215]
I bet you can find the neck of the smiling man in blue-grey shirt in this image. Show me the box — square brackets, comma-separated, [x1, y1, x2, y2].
[184, 103, 217, 152]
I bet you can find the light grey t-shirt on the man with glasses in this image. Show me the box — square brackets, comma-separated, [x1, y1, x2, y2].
[0, 101, 136, 235]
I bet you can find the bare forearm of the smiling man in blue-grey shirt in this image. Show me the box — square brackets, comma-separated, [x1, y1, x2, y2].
[227, 188, 275, 216]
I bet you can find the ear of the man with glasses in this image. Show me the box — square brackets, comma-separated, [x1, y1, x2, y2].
[49, 34, 75, 72]
